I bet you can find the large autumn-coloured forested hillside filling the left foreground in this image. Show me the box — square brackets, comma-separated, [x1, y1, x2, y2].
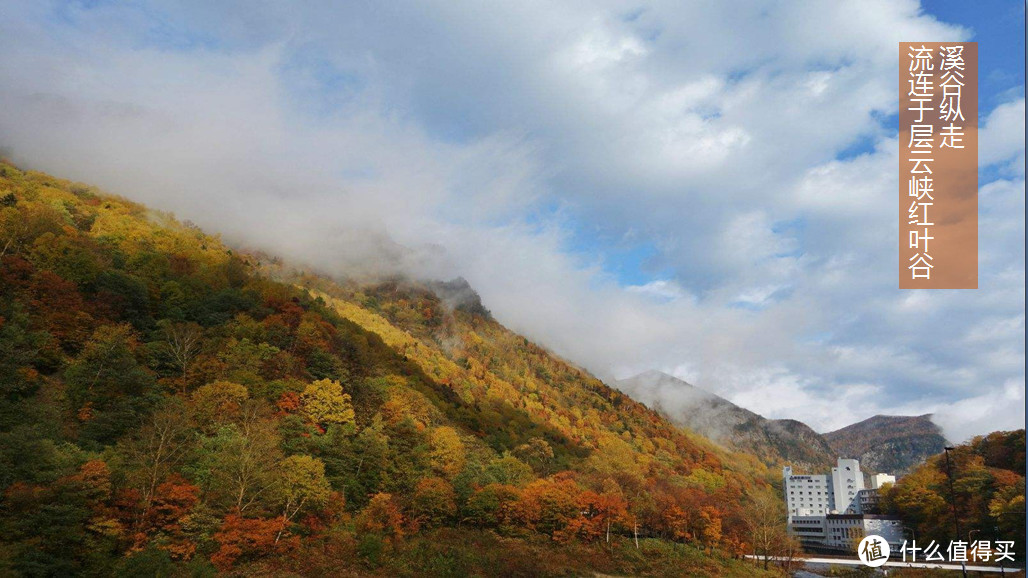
[0, 159, 777, 576]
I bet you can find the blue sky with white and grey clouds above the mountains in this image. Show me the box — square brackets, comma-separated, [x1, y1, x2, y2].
[0, 0, 1025, 438]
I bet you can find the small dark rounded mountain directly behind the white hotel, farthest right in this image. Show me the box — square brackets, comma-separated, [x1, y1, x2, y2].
[824, 413, 947, 475]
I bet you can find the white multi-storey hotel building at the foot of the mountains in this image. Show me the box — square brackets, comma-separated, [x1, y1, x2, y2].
[782, 458, 903, 550]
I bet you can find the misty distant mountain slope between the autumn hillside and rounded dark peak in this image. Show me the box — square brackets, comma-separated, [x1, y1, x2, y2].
[617, 371, 835, 471]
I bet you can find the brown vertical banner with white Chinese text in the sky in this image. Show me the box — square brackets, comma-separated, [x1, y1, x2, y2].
[900, 42, 978, 289]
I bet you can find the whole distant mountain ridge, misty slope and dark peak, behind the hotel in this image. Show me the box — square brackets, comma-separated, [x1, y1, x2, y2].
[616, 371, 947, 475]
